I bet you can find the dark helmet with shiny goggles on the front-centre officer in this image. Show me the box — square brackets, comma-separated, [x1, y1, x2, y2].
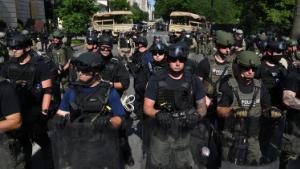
[167, 43, 189, 62]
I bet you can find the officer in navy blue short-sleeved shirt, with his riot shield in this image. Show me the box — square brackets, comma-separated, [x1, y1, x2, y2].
[53, 52, 125, 169]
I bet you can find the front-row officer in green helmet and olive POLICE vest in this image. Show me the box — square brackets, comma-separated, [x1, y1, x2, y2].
[217, 51, 281, 169]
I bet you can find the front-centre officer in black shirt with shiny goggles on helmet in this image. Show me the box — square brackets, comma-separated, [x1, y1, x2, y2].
[144, 45, 206, 169]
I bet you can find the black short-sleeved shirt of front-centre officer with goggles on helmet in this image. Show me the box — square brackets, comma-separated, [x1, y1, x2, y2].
[145, 72, 205, 101]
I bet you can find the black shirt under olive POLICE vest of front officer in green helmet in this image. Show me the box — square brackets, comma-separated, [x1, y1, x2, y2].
[218, 80, 271, 109]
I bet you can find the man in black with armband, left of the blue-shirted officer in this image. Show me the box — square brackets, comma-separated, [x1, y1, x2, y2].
[2, 34, 53, 169]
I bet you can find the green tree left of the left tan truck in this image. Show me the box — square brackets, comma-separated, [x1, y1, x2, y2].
[56, 0, 96, 34]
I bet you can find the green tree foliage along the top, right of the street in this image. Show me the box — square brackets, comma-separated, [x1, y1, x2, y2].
[154, 0, 296, 32]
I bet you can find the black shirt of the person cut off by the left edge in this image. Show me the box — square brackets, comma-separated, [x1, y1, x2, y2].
[0, 81, 20, 117]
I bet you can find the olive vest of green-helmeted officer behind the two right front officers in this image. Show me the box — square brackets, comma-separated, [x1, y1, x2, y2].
[204, 55, 232, 97]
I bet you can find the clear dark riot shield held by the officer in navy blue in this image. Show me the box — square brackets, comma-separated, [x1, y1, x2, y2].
[49, 117, 121, 169]
